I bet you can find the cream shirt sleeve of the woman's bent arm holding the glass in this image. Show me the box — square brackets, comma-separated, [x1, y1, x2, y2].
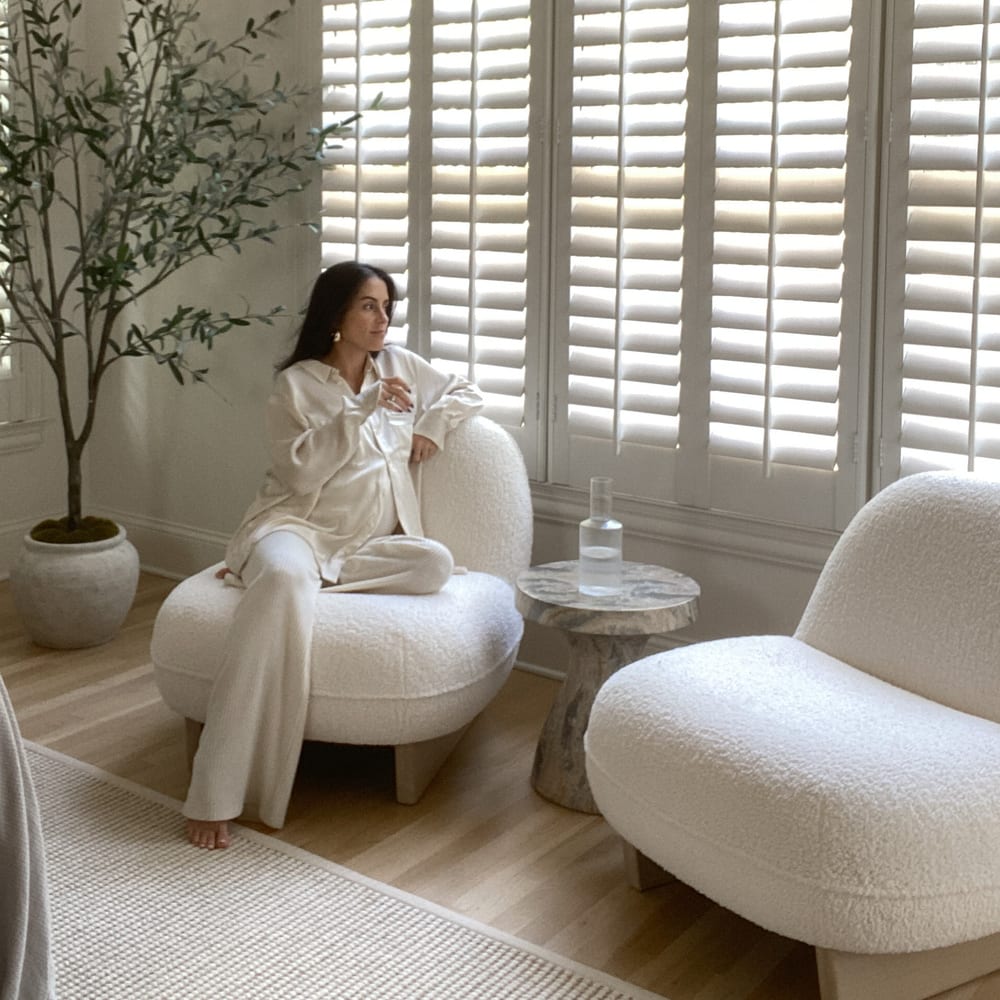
[267, 372, 379, 494]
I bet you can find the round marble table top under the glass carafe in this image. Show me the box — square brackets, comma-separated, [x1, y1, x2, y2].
[516, 559, 701, 635]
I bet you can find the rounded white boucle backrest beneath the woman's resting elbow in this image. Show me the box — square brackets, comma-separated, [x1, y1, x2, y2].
[417, 414, 532, 586]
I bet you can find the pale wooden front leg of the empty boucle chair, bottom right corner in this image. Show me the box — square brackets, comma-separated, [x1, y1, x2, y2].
[816, 934, 1000, 1000]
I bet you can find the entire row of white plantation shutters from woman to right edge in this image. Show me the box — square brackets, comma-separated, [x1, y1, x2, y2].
[314, 0, 1000, 528]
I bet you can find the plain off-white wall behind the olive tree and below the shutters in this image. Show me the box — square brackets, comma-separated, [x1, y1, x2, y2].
[0, 0, 834, 672]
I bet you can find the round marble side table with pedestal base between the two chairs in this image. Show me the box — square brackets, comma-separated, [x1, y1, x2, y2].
[516, 559, 701, 813]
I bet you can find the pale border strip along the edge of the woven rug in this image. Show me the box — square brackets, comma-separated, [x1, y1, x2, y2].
[22, 739, 667, 1000]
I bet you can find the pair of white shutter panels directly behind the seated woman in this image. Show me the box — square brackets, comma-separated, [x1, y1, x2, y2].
[323, 0, 547, 460]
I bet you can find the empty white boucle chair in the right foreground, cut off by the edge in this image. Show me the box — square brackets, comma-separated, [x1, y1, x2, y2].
[586, 473, 1000, 1000]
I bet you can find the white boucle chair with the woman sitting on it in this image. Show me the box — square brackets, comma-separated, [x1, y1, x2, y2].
[151, 416, 532, 803]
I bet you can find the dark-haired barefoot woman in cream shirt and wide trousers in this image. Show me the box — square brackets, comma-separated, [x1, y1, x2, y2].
[184, 261, 482, 849]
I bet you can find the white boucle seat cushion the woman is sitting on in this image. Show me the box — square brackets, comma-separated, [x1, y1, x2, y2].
[151, 564, 524, 745]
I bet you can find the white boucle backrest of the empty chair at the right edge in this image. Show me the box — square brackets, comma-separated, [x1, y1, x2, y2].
[795, 472, 1000, 721]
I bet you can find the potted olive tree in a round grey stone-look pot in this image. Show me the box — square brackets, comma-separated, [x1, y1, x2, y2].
[0, 0, 350, 647]
